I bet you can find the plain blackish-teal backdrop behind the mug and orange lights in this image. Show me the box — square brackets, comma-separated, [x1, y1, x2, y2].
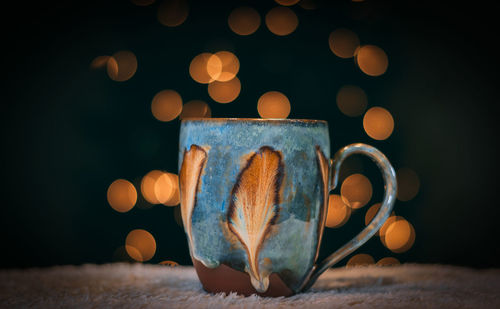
[0, 0, 500, 267]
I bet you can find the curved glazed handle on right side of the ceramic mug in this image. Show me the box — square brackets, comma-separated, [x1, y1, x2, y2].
[300, 143, 397, 292]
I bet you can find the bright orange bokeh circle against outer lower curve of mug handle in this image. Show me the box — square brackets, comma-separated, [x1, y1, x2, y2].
[383, 218, 415, 253]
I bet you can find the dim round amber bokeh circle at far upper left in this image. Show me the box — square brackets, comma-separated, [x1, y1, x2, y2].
[106, 50, 137, 82]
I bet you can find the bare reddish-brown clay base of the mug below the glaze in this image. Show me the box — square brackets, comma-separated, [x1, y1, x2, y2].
[193, 259, 294, 297]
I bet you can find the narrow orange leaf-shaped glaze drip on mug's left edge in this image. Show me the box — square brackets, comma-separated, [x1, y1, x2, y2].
[179, 144, 207, 255]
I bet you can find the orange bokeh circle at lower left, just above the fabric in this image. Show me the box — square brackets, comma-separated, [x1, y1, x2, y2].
[125, 229, 156, 262]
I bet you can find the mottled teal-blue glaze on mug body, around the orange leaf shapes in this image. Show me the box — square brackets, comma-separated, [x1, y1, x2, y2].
[179, 119, 330, 292]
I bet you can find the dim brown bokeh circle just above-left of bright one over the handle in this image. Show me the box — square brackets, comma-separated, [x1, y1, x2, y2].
[337, 85, 368, 117]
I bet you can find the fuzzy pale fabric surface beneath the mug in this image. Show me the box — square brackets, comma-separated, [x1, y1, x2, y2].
[0, 264, 500, 309]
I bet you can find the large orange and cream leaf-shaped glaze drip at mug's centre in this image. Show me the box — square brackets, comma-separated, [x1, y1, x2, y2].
[227, 146, 284, 292]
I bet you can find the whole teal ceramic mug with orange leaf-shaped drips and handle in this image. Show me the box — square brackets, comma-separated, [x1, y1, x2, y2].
[179, 118, 396, 296]
